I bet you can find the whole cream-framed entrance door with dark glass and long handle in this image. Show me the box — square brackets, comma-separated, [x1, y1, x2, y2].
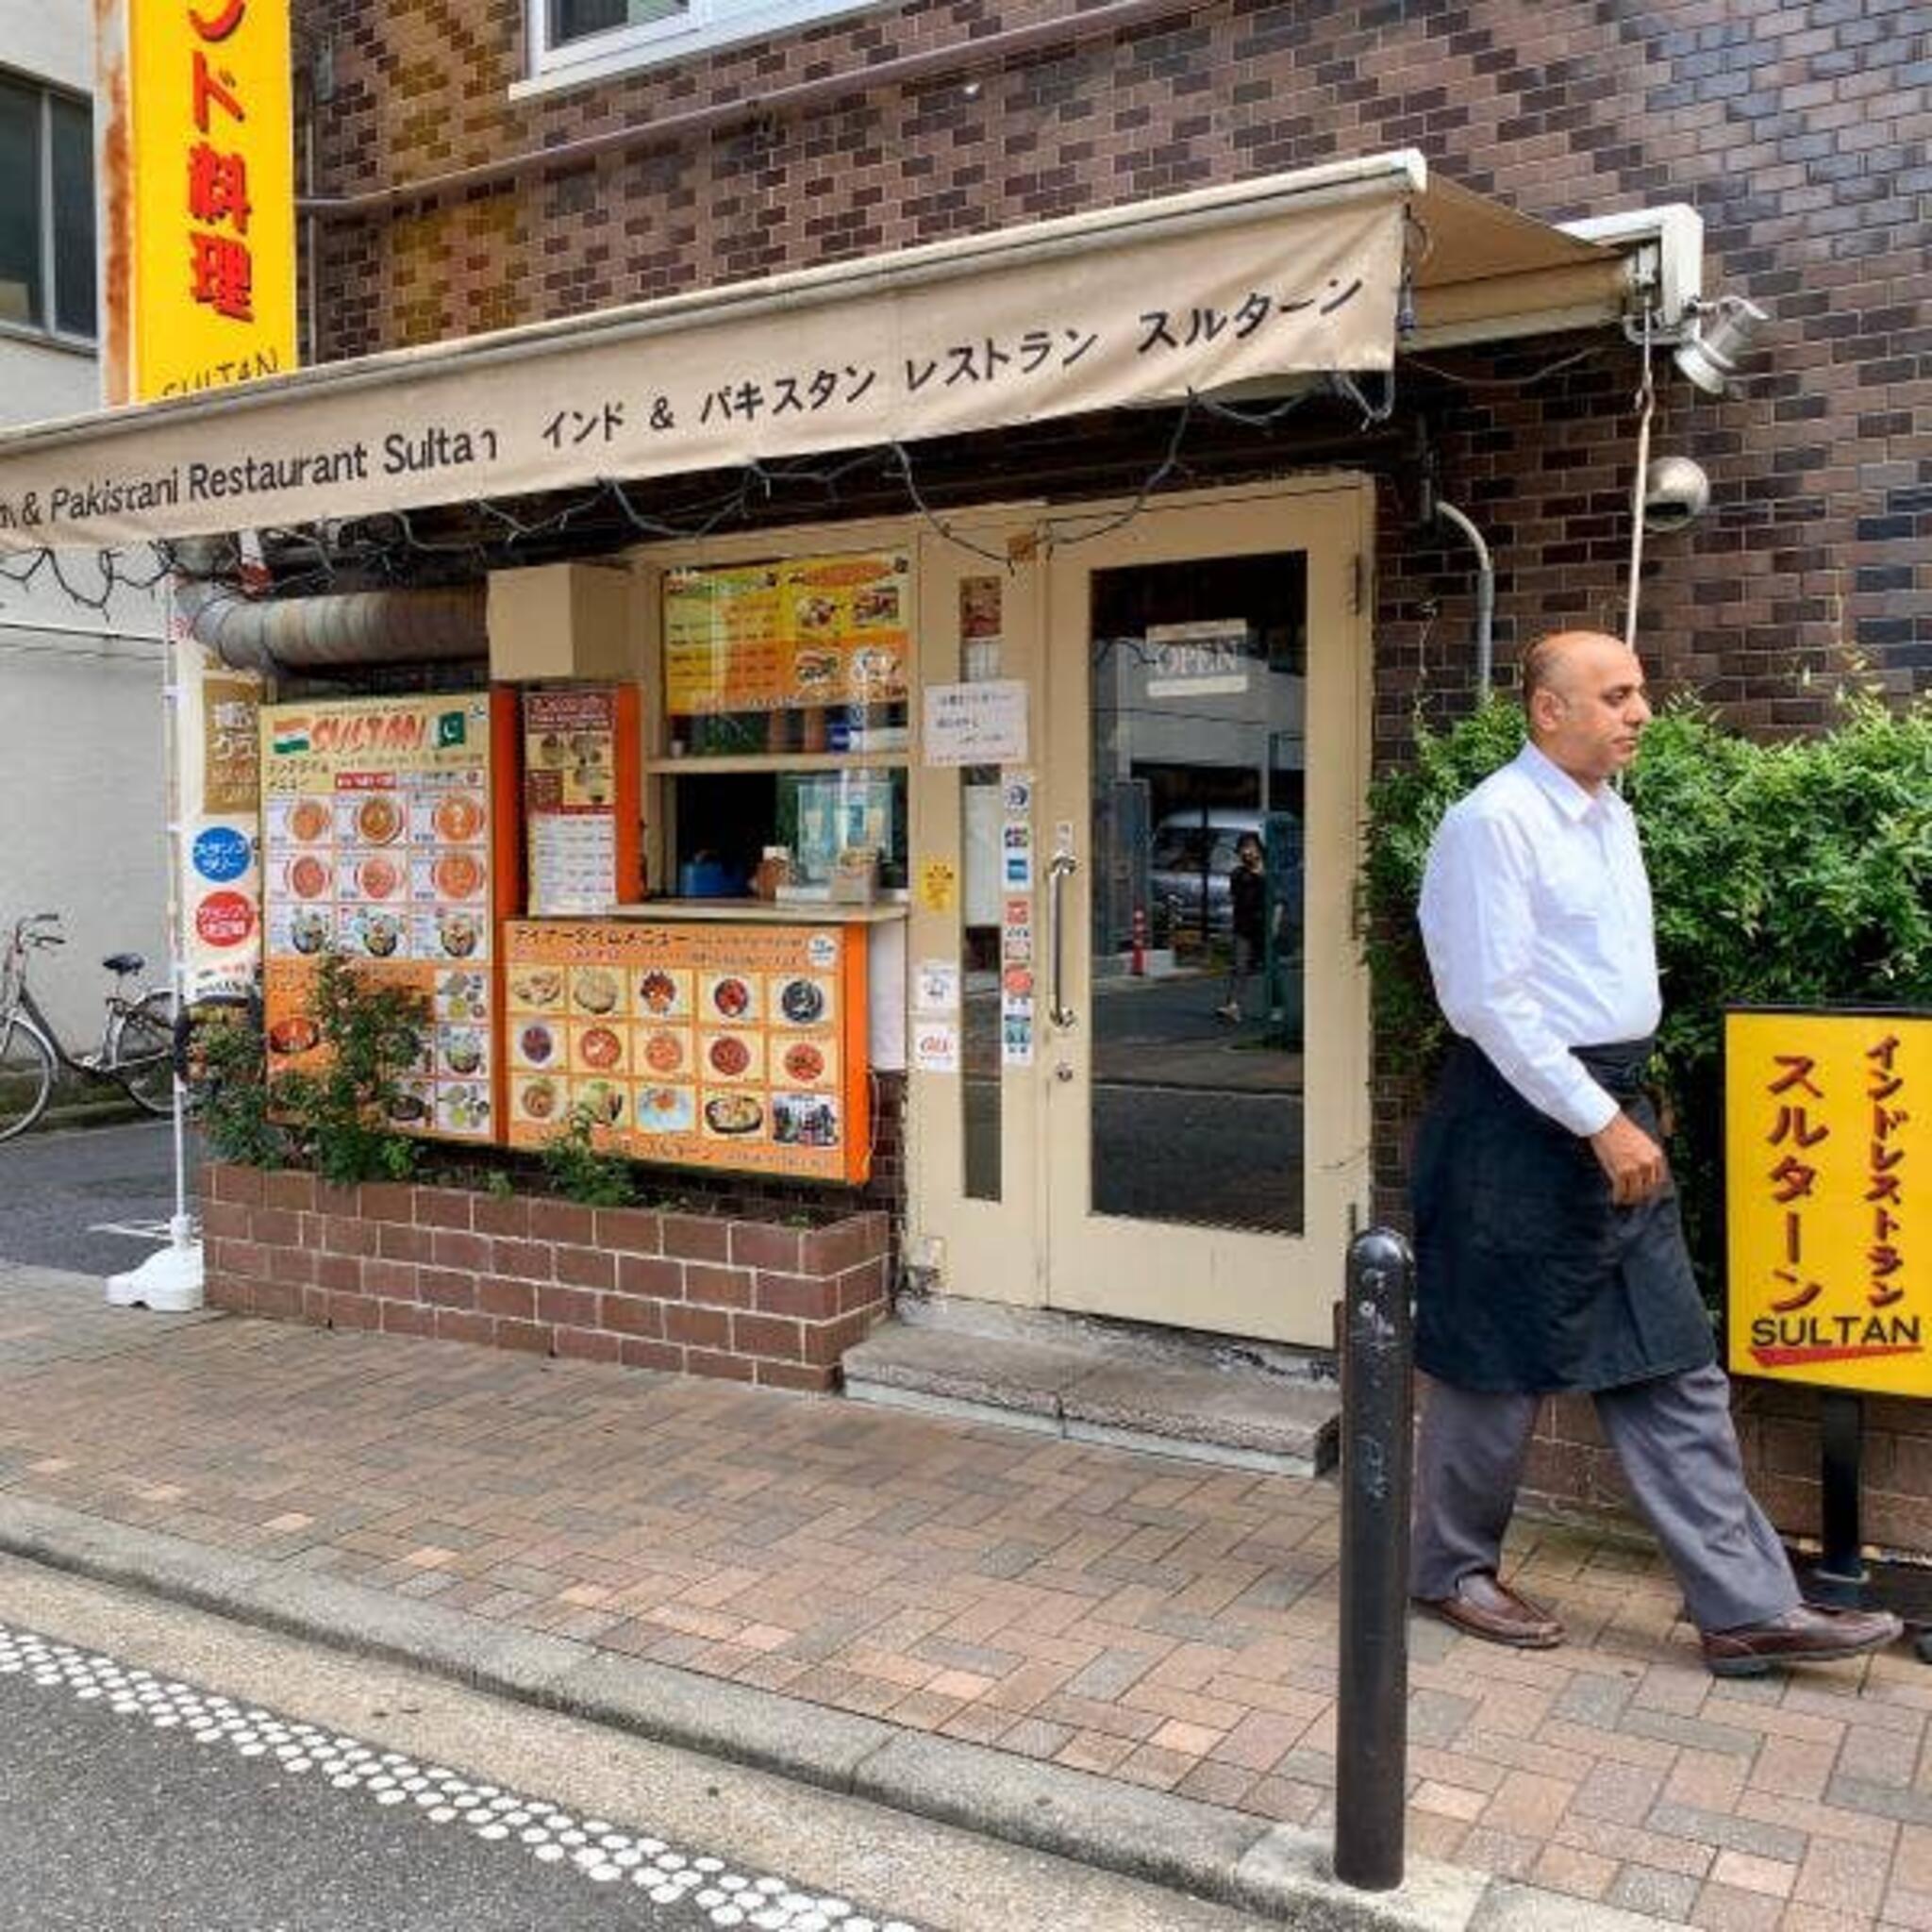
[1041, 491, 1368, 1342]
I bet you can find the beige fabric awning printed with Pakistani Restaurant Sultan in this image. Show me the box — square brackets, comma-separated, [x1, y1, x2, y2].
[0, 151, 1624, 551]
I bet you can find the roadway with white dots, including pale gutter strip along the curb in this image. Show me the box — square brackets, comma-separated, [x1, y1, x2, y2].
[0, 1557, 1256, 1932]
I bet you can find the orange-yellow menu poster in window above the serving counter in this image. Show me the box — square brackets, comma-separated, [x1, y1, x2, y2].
[665, 553, 912, 717]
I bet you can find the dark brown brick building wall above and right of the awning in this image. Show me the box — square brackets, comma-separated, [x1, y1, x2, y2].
[299, 0, 1932, 695]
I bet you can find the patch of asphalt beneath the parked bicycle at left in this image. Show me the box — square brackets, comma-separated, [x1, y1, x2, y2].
[0, 1121, 193, 1275]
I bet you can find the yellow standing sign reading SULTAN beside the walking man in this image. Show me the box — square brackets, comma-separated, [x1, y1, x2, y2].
[1724, 1010, 1932, 1395]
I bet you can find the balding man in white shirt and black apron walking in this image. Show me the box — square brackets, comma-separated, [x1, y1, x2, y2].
[1412, 632, 1899, 1677]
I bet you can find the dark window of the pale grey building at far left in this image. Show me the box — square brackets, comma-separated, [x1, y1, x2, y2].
[0, 74, 94, 341]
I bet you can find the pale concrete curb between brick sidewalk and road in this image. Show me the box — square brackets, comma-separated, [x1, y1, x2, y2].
[0, 1495, 1657, 1932]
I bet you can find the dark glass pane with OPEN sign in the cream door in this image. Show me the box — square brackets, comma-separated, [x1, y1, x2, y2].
[1086, 551, 1307, 1235]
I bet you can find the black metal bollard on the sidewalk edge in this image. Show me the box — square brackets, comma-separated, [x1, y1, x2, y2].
[1335, 1226, 1416, 1891]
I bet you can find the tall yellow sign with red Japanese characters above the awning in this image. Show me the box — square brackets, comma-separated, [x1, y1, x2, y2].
[100, 0, 295, 402]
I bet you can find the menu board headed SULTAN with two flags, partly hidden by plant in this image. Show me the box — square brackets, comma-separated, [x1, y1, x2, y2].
[260, 691, 514, 1140]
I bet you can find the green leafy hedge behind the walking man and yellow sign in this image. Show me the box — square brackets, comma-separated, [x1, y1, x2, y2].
[1362, 695, 1932, 1296]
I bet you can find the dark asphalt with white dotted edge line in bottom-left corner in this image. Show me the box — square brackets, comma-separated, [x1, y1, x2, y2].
[0, 1628, 776, 1932]
